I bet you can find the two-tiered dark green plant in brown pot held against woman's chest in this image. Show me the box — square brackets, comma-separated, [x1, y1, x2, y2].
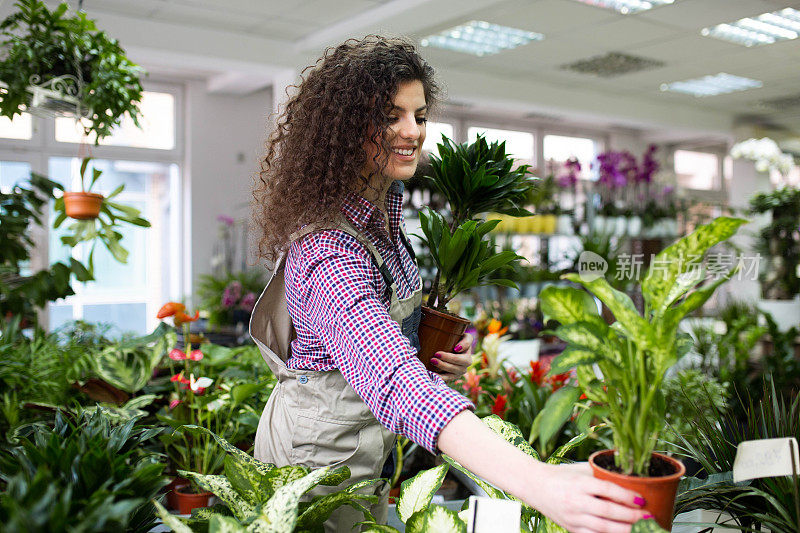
[419, 136, 535, 365]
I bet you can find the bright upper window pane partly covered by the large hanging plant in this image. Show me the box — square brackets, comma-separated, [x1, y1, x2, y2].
[56, 91, 175, 150]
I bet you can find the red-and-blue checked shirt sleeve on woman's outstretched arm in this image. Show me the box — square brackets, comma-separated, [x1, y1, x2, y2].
[289, 234, 474, 453]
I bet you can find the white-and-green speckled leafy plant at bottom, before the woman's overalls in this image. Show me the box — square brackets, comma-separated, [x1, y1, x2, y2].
[156, 426, 379, 533]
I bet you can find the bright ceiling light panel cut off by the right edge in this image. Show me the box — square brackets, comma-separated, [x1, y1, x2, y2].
[700, 7, 800, 46]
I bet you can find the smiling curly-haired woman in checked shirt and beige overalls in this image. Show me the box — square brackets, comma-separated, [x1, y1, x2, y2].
[250, 36, 644, 532]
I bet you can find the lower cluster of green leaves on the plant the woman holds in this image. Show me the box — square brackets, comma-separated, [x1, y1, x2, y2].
[419, 209, 522, 311]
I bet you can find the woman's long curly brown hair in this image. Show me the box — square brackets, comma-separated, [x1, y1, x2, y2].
[253, 35, 440, 261]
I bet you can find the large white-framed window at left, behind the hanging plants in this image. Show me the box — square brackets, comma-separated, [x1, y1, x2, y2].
[0, 84, 186, 333]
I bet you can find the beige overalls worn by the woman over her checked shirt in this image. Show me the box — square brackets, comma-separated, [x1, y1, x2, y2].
[250, 219, 422, 533]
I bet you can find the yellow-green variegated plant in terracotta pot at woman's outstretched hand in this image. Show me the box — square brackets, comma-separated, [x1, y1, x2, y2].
[540, 217, 746, 530]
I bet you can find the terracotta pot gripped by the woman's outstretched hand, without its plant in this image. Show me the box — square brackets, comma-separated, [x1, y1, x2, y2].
[589, 450, 686, 531]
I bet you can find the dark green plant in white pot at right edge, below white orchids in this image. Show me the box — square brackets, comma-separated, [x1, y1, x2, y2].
[750, 187, 800, 331]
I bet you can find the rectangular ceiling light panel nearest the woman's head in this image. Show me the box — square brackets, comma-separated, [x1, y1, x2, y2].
[420, 20, 544, 56]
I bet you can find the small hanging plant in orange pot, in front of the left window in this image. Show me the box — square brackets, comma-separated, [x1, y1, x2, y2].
[53, 157, 150, 273]
